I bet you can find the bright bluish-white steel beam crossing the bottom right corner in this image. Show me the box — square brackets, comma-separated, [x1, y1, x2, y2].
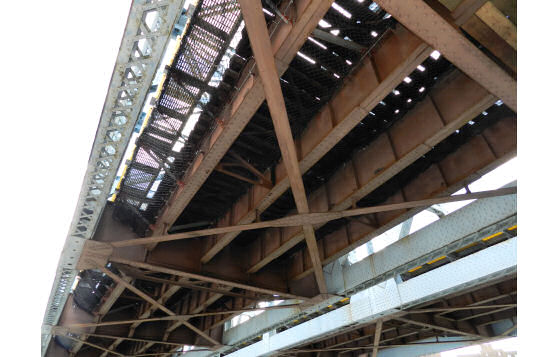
[223, 238, 517, 357]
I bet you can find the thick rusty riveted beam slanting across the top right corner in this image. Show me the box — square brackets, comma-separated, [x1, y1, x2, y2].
[377, 0, 517, 113]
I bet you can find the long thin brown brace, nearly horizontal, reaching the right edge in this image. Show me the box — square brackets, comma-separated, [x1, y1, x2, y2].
[110, 187, 517, 248]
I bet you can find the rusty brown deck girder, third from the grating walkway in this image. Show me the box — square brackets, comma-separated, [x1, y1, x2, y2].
[248, 70, 495, 273]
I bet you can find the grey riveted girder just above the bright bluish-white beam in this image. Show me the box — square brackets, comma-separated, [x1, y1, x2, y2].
[327, 186, 517, 294]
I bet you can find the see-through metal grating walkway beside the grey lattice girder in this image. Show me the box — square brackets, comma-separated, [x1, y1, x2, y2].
[115, 0, 241, 234]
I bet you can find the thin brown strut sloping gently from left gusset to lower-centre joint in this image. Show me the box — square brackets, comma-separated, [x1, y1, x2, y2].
[110, 257, 307, 300]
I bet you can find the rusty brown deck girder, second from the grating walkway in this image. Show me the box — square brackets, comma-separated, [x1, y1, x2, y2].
[201, 27, 432, 263]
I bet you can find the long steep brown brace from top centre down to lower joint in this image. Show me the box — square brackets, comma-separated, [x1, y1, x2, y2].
[239, 0, 328, 294]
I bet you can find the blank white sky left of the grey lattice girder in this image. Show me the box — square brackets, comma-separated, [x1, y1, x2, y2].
[0, 0, 131, 356]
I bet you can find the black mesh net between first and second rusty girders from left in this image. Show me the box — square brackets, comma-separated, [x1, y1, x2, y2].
[176, 1, 395, 231]
